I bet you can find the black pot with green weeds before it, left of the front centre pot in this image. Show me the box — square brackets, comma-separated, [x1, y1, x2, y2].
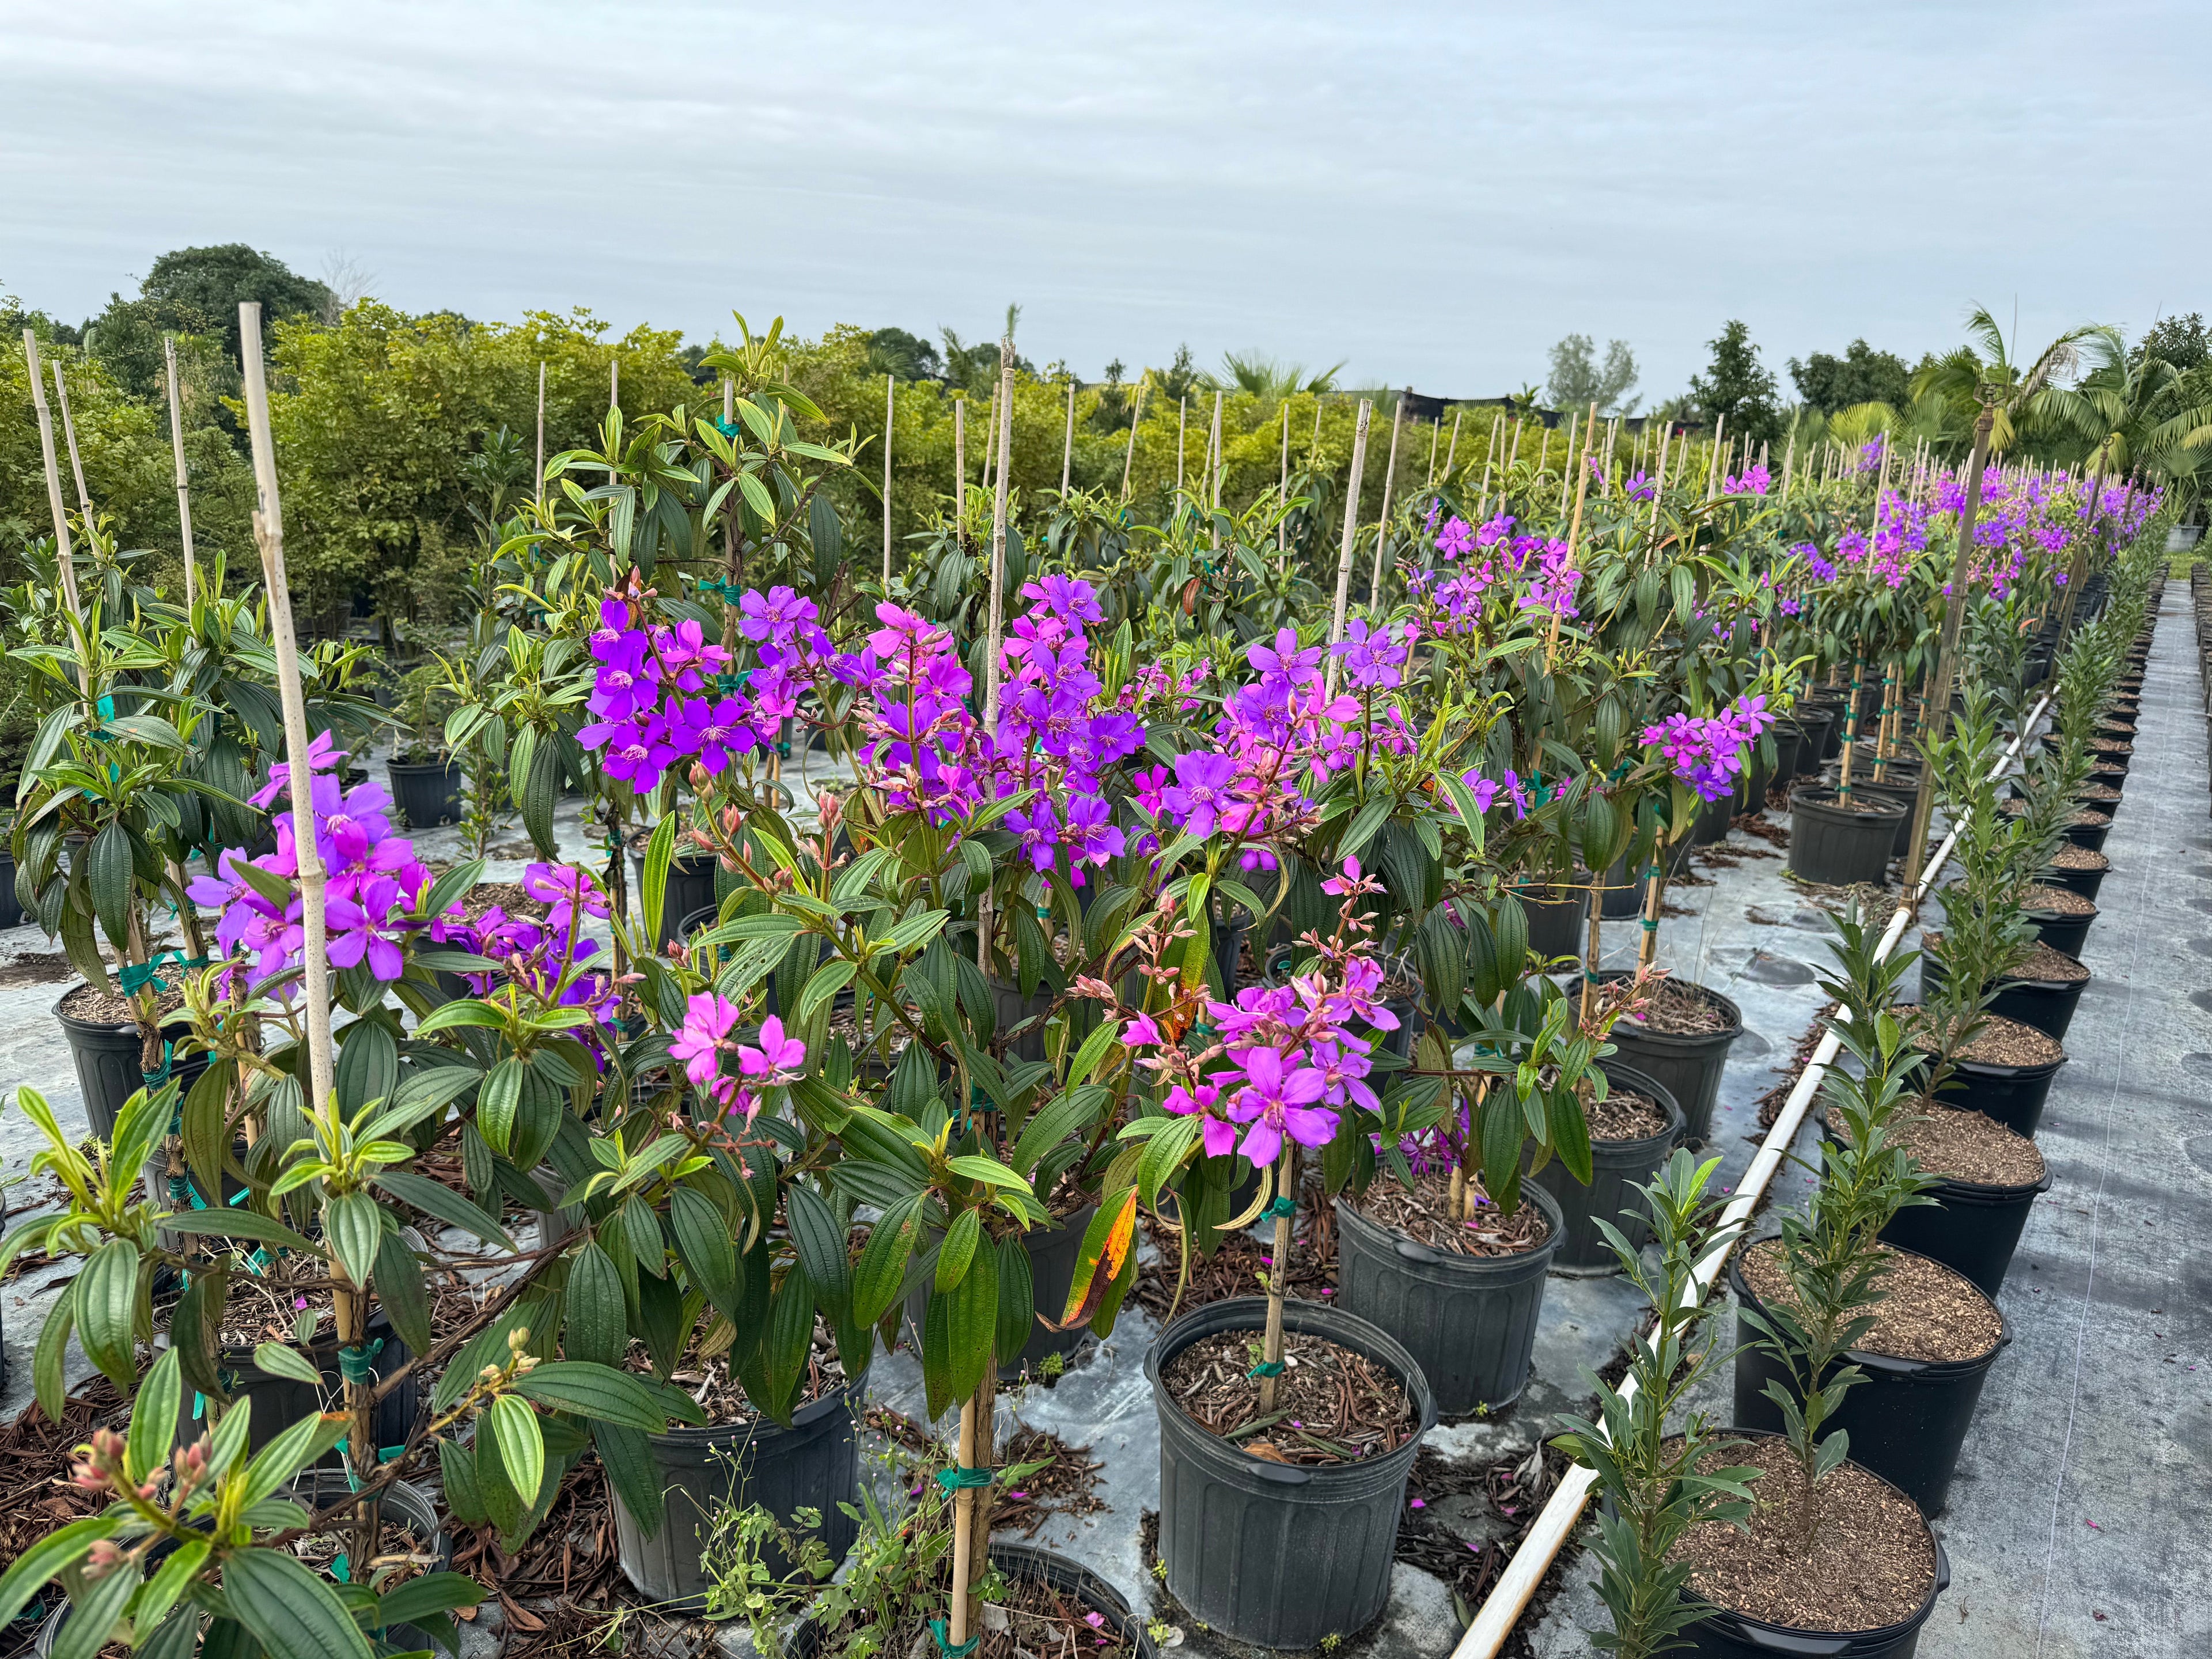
[615, 1374, 867, 1611]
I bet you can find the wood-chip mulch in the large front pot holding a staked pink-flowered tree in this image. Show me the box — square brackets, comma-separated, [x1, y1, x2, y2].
[1159, 1330, 1420, 1464]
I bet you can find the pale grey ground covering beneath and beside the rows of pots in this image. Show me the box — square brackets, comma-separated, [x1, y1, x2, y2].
[0, 601, 2212, 1659]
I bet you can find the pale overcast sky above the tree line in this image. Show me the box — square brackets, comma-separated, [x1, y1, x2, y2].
[0, 0, 2212, 396]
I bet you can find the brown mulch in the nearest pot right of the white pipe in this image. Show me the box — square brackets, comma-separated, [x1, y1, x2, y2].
[1670, 1435, 1936, 1630]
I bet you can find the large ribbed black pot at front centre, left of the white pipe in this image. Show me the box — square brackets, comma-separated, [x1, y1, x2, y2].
[1143, 1309, 1435, 1648]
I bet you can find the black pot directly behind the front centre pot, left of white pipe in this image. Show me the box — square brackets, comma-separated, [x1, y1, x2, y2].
[1336, 1181, 1566, 1418]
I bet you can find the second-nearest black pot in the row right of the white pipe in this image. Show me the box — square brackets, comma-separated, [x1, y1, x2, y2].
[1728, 1261, 2013, 1517]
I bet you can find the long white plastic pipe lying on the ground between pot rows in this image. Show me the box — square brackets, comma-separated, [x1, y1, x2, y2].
[1451, 692, 2051, 1659]
